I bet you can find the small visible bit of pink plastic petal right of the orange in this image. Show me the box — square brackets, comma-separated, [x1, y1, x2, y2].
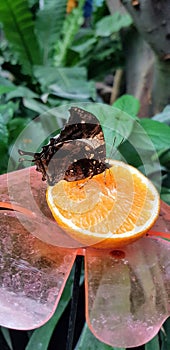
[149, 201, 170, 239]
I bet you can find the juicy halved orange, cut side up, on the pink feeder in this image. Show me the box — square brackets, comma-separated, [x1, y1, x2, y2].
[47, 160, 160, 248]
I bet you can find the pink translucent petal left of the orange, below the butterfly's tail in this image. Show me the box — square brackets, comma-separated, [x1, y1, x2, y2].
[0, 167, 85, 248]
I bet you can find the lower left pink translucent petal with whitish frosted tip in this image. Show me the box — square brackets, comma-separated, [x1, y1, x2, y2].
[0, 210, 76, 330]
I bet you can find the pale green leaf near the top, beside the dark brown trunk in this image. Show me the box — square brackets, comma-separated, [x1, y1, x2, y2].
[96, 12, 132, 37]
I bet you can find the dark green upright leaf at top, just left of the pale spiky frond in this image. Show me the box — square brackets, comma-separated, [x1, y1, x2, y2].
[35, 0, 67, 64]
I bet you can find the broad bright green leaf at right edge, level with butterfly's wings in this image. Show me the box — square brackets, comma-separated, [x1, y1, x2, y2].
[140, 118, 170, 151]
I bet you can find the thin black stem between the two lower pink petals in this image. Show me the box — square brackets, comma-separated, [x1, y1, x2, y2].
[66, 255, 83, 350]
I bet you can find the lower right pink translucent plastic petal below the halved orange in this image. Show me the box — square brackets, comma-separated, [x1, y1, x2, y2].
[85, 237, 170, 347]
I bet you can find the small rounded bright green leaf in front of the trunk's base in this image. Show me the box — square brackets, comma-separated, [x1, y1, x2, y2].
[113, 95, 140, 117]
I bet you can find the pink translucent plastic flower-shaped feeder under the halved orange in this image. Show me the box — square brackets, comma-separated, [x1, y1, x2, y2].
[0, 167, 170, 347]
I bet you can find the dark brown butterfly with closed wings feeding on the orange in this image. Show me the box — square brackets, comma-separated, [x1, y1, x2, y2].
[19, 107, 110, 186]
